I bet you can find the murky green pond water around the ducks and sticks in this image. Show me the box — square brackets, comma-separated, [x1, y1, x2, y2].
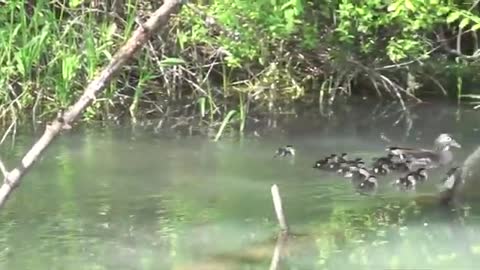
[0, 101, 480, 269]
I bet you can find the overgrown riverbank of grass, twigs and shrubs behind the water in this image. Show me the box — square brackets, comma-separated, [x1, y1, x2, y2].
[0, 1, 480, 134]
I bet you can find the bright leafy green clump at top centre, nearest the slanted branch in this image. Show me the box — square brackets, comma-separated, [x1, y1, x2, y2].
[178, 0, 313, 67]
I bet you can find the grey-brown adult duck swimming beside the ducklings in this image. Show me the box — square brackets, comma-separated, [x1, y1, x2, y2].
[387, 133, 461, 169]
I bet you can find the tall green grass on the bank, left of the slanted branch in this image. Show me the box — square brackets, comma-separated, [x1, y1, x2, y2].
[0, 0, 147, 124]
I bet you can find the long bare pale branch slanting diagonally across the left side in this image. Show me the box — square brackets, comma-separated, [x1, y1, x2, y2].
[0, 0, 182, 207]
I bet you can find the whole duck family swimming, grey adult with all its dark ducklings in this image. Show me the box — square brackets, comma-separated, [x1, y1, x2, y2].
[275, 133, 461, 193]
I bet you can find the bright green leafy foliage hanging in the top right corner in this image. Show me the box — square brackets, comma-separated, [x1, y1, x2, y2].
[336, 0, 480, 62]
